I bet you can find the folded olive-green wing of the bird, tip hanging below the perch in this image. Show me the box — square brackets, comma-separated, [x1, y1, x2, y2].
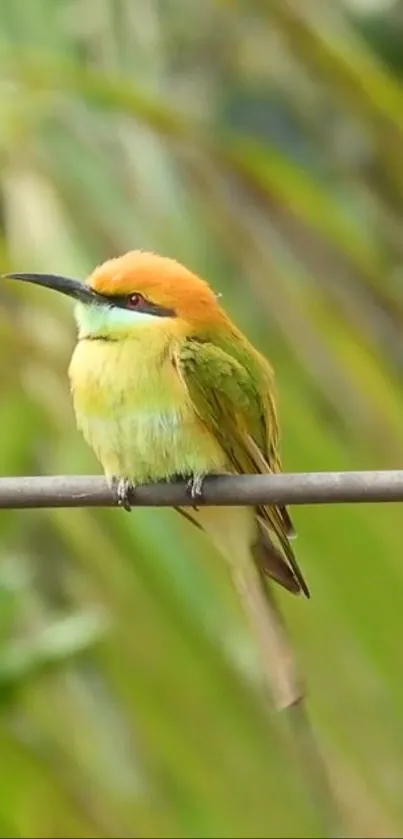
[175, 340, 309, 596]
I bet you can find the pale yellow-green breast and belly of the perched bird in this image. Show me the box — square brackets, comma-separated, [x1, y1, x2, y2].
[69, 330, 225, 483]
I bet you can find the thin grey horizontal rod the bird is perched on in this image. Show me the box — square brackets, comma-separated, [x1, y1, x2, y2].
[0, 469, 403, 509]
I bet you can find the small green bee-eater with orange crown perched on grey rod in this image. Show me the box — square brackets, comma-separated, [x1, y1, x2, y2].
[3, 250, 309, 636]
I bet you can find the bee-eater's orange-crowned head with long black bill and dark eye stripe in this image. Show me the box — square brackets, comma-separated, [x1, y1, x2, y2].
[1, 251, 225, 339]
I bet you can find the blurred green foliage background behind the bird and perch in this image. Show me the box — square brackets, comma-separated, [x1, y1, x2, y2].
[0, 0, 403, 837]
